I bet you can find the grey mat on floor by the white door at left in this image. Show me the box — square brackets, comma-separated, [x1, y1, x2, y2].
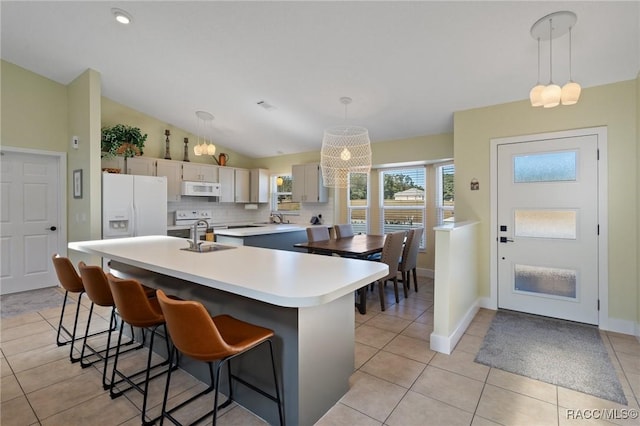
[0, 287, 64, 318]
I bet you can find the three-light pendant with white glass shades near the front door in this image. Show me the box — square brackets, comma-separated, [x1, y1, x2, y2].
[529, 11, 581, 108]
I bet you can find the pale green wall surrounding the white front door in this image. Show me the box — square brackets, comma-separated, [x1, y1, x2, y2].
[454, 80, 639, 321]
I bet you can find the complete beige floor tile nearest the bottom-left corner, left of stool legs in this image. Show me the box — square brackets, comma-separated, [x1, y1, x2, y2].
[27, 368, 104, 419]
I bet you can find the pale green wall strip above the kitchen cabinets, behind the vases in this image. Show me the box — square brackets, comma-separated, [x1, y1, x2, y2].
[102, 97, 253, 168]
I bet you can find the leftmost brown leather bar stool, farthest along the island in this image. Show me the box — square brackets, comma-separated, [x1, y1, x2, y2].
[51, 253, 107, 362]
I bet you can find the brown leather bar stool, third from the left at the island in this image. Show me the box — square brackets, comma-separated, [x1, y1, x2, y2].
[107, 274, 177, 425]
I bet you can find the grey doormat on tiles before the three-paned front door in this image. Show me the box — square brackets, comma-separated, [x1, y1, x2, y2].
[475, 310, 627, 405]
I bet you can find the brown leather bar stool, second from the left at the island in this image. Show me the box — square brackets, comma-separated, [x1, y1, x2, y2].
[78, 261, 144, 390]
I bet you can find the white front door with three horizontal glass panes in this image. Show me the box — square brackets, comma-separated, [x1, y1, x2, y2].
[497, 135, 598, 324]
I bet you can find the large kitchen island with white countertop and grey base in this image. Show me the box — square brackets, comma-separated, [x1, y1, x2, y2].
[69, 236, 388, 425]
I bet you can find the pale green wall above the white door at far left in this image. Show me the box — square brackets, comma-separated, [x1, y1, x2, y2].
[0, 61, 69, 152]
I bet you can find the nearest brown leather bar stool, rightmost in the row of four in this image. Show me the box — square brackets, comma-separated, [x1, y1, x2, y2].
[156, 290, 284, 425]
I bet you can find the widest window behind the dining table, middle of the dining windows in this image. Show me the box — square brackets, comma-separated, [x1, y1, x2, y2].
[380, 167, 426, 247]
